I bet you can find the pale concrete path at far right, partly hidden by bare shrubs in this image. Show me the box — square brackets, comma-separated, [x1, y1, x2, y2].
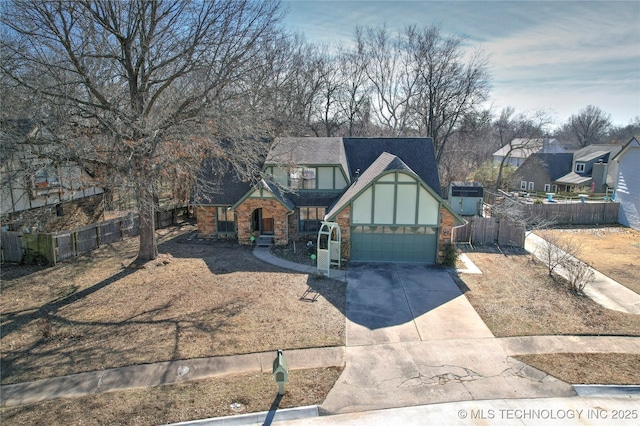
[524, 232, 640, 315]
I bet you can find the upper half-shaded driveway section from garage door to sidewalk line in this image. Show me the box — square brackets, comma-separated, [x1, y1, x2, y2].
[347, 263, 493, 346]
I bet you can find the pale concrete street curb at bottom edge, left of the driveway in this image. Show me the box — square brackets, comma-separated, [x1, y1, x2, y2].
[166, 405, 319, 426]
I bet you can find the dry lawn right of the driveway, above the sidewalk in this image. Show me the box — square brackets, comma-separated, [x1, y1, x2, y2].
[457, 250, 640, 337]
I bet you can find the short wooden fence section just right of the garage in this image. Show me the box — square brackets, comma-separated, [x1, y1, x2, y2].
[455, 216, 525, 248]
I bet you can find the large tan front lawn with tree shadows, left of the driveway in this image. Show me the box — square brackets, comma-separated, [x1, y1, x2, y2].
[0, 226, 345, 384]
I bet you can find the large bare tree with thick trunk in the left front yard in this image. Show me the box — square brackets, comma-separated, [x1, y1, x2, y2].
[1, 0, 280, 261]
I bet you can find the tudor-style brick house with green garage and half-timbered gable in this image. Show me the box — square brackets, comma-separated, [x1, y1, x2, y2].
[191, 137, 463, 263]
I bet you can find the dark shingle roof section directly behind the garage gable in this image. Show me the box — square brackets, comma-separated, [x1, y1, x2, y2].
[344, 138, 442, 196]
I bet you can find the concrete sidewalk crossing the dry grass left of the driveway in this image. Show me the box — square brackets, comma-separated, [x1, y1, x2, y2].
[0, 346, 345, 406]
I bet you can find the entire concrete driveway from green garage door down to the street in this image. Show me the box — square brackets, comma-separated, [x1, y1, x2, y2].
[321, 264, 575, 413]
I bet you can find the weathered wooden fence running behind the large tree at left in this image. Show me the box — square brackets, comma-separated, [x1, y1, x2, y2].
[2, 207, 189, 265]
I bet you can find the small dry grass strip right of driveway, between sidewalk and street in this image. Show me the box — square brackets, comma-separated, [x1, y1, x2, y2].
[514, 353, 640, 385]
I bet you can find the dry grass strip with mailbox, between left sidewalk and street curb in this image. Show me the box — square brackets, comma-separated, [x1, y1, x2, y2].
[0, 368, 341, 426]
